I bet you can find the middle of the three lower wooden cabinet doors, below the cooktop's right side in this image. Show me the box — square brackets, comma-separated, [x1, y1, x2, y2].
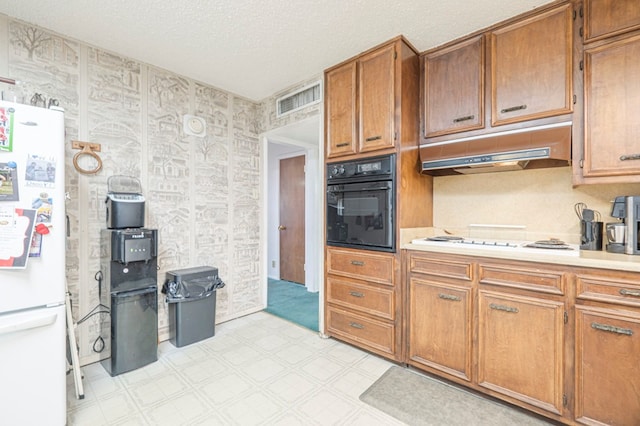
[478, 290, 565, 414]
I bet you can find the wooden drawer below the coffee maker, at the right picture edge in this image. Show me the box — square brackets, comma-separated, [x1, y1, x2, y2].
[576, 274, 640, 308]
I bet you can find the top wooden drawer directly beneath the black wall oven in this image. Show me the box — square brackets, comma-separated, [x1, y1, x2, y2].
[327, 248, 395, 285]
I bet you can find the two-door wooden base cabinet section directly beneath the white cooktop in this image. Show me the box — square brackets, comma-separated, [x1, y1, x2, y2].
[403, 250, 572, 423]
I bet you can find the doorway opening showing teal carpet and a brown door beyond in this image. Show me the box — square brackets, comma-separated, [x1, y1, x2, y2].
[263, 115, 324, 331]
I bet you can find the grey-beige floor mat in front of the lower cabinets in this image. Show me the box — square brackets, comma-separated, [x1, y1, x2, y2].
[360, 366, 552, 426]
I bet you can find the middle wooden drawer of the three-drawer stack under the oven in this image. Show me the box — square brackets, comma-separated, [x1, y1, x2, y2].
[327, 276, 395, 320]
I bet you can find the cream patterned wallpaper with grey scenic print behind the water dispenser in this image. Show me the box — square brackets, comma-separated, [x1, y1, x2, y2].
[0, 15, 300, 364]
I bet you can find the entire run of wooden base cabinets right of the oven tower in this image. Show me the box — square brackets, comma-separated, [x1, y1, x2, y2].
[403, 250, 640, 426]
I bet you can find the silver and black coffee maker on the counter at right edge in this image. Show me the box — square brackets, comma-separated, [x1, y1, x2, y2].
[606, 195, 640, 254]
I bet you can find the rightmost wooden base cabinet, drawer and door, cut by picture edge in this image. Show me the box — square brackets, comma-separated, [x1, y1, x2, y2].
[574, 269, 640, 426]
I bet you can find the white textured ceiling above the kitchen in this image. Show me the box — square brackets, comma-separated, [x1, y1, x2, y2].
[0, 0, 549, 101]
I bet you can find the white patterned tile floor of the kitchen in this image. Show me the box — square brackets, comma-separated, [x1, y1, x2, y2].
[67, 312, 403, 426]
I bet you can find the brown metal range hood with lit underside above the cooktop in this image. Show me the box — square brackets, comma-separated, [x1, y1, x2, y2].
[420, 122, 571, 176]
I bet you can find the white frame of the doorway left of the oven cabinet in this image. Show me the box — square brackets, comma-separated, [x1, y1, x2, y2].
[261, 114, 325, 333]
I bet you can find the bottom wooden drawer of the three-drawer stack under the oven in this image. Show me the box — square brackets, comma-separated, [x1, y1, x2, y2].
[327, 307, 395, 355]
